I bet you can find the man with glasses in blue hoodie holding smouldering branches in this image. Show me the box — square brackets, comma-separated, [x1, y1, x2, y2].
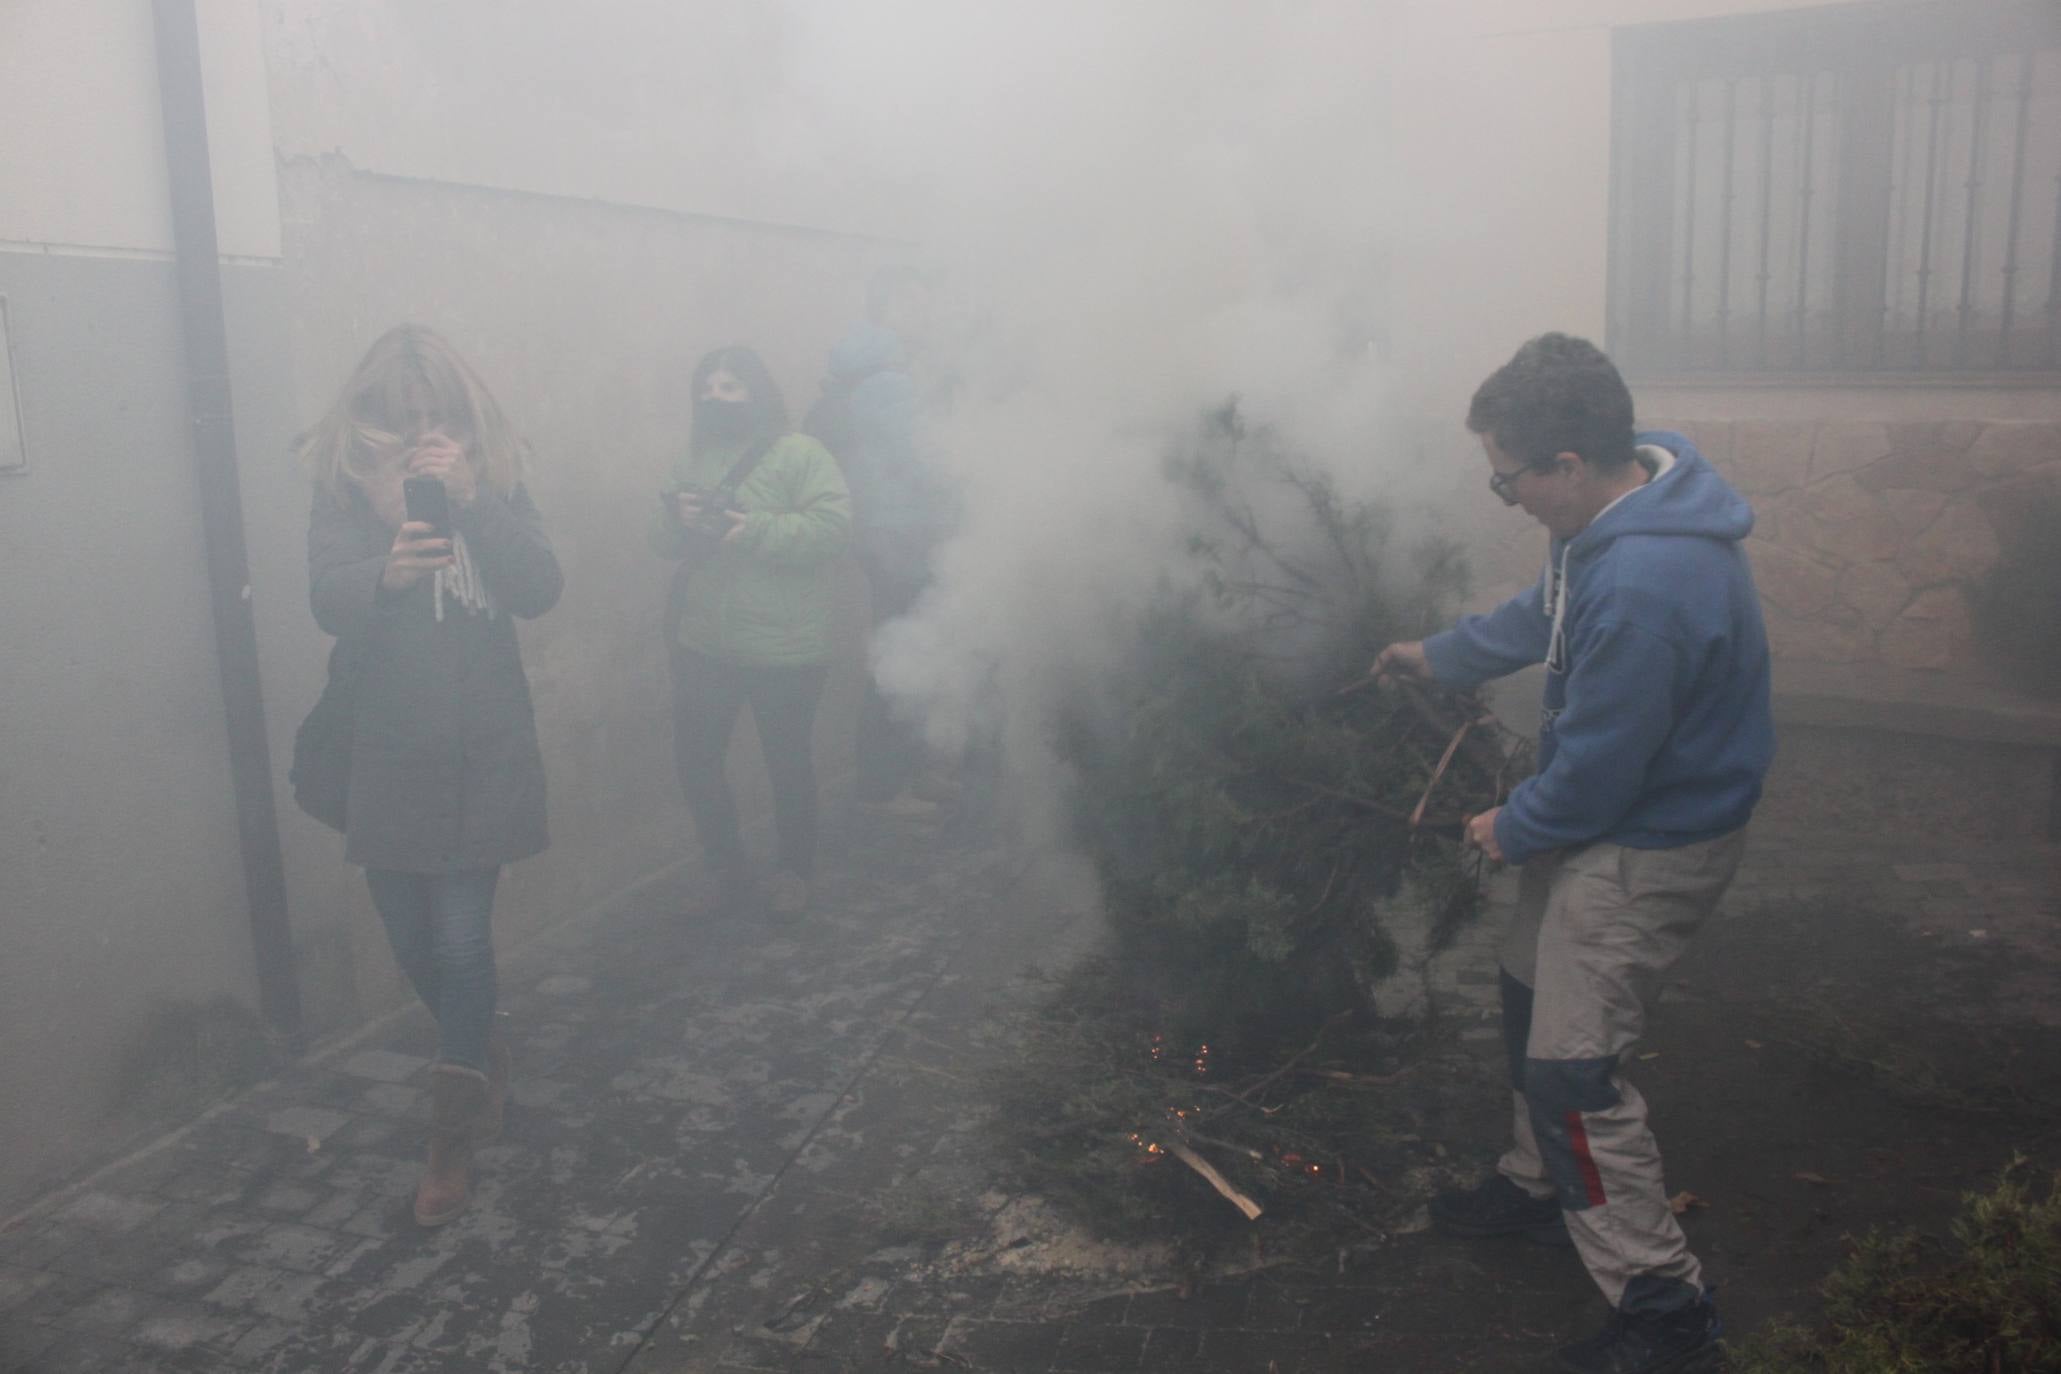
[1375, 334, 1775, 1374]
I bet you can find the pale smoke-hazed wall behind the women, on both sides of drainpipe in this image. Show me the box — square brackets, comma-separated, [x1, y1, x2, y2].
[0, 0, 882, 1215]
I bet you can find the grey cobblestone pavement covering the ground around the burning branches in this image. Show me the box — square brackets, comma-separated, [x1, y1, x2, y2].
[0, 834, 2061, 1374]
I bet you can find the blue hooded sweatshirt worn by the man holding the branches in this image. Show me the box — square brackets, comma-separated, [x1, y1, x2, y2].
[1424, 431, 1775, 863]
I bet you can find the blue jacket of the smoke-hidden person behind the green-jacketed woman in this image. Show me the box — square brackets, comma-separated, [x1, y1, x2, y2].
[824, 321, 950, 558]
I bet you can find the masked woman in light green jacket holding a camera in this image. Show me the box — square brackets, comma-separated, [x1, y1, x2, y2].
[651, 348, 851, 917]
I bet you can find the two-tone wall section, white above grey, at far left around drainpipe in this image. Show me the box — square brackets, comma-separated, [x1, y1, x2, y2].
[0, 0, 286, 1211]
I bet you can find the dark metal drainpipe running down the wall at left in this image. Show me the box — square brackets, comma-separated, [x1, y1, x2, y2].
[153, 0, 303, 1051]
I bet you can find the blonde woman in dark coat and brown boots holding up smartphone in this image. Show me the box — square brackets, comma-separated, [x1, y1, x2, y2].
[301, 325, 563, 1226]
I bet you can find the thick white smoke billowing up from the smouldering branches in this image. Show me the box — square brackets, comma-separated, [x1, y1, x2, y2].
[769, 0, 1459, 832]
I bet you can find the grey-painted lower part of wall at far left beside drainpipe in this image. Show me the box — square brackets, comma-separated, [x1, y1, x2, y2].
[0, 253, 291, 1199]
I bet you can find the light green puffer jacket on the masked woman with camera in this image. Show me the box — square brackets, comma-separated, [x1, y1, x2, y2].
[651, 435, 851, 667]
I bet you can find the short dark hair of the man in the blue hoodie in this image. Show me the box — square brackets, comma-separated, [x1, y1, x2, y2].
[1467, 334, 1634, 472]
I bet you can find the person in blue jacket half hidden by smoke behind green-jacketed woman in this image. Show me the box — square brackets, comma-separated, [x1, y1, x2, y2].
[804, 266, 956, 820]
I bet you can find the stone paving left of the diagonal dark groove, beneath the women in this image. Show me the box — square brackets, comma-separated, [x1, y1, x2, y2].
[0, 823, 1071, 1372]
